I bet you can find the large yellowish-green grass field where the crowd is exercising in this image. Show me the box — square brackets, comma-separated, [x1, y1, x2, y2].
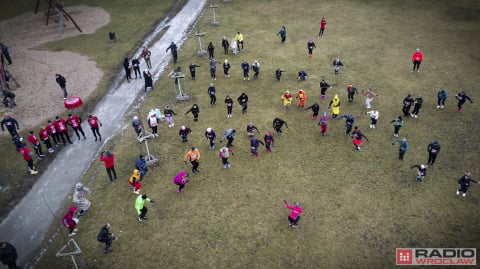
[10, 0, 480, 268]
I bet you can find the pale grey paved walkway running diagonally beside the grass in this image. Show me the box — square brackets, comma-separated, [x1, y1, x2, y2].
[0, 0, 206, 268]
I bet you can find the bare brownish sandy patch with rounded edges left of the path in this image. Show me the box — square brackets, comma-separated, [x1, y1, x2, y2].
[0, 6, 110, 131]
